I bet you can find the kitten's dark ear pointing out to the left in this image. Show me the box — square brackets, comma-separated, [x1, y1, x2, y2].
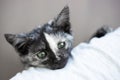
[5, 34, 32, 55]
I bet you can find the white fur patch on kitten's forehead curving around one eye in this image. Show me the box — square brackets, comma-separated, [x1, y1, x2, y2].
[44, 33, 73, 60]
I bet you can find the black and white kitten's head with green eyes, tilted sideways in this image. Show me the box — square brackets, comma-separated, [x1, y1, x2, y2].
[5, 6, 73, 69]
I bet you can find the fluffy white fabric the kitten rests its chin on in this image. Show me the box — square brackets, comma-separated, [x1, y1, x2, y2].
[10, 28, 120, 80]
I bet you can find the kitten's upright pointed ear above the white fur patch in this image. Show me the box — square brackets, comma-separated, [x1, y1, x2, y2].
[54, 6, 70, 33]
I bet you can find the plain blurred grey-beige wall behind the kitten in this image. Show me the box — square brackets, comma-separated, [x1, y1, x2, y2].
[0, 0, 120, 80]
